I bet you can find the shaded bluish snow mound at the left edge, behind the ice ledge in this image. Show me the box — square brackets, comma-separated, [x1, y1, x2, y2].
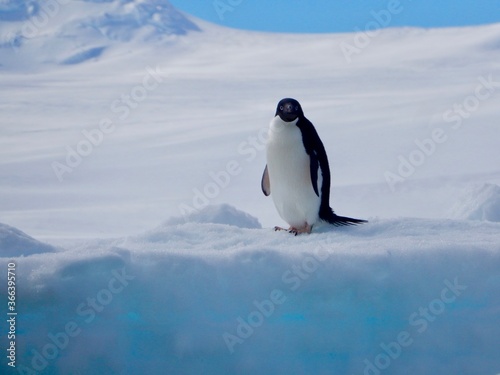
[0, 223, 56, 258]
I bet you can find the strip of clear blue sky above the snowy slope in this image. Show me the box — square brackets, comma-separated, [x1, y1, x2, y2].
[170, 0, 500, 33]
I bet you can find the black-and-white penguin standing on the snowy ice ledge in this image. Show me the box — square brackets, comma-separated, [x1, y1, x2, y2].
[261, 98, 366, 235]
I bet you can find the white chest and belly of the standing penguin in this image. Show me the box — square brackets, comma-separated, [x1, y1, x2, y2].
[266, 116, 322, 227]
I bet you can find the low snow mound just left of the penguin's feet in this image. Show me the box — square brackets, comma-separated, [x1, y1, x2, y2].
[165, 204, 262, 229]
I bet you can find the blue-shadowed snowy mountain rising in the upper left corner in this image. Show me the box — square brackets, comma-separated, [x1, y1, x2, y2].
[0, 0, 200, 69]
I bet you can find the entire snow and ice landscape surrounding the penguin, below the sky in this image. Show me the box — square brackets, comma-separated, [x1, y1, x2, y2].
[0, 0, 500, 375]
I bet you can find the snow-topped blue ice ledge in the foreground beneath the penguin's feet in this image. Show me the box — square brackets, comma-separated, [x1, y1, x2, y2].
[0, 217, 500, 375]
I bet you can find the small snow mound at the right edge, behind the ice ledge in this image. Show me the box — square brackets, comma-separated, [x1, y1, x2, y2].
[452, 184, 500, 222]
